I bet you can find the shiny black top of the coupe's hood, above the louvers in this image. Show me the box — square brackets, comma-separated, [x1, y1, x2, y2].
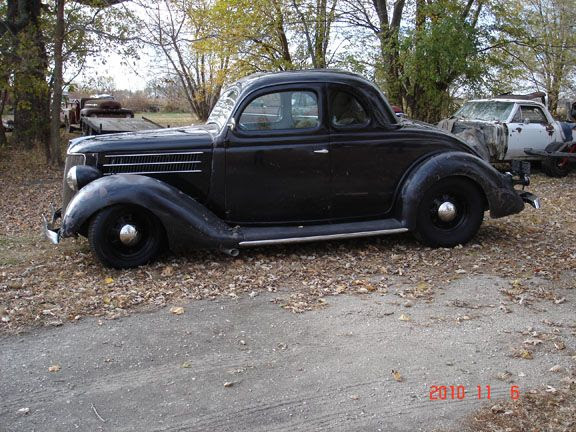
[68, 125, 218, 153]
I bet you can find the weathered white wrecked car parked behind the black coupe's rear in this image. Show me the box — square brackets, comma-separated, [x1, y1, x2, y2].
[438, 95, 576, 177]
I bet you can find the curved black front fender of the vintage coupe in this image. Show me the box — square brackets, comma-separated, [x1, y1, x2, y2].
[60, 174, 241, 248]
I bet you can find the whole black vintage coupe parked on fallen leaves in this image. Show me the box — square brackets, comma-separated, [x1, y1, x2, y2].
[44, 71, 538, 268]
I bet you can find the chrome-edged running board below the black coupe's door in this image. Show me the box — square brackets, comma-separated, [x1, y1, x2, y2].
[239, 219, 408, 247]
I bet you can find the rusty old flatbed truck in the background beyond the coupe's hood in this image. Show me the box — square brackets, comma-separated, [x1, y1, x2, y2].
[60, 95, 162, 135]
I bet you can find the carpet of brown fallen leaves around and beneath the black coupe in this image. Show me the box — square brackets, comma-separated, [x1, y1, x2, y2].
[0, 145, 576, 331]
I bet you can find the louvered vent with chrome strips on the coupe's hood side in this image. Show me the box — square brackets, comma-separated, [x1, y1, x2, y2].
[102, 152, 202, 175]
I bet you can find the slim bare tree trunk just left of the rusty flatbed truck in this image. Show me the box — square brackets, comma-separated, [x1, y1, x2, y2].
[49, 0, 65, 166]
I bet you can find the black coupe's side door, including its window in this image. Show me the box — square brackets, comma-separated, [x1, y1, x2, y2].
[225, 84, 330, 225]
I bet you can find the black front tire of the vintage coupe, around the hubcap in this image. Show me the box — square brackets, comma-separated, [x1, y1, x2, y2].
[88, 205, 165, 268]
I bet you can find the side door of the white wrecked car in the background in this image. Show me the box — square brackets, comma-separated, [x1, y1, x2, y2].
[505, 104, 556, 160]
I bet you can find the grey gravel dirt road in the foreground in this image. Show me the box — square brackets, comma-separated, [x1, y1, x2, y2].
[0, 276, 576, 432]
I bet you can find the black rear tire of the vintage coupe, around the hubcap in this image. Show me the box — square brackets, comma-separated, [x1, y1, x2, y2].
[414, 177, 484, 247]
